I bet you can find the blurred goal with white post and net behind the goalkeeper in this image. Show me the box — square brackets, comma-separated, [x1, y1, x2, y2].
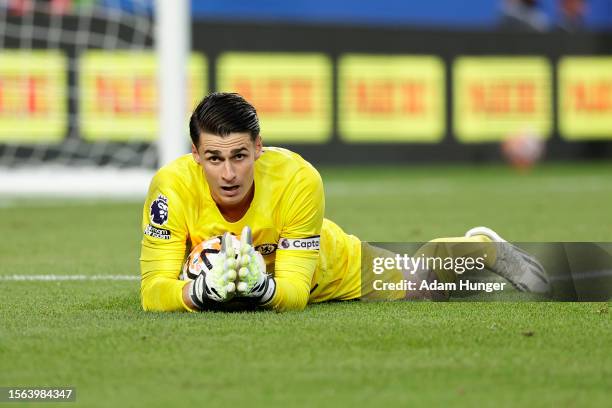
[0, 0, 190, 196]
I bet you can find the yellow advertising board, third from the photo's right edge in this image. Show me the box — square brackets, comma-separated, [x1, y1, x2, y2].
[338, 54, 446, 143]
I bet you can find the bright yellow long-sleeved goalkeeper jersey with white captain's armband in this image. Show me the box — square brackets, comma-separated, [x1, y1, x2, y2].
[140, 147, 361, 311]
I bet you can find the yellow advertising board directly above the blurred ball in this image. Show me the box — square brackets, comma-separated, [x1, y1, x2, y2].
[453, 56, 552, 143]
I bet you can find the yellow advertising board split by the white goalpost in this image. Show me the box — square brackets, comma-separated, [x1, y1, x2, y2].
[79, 51, 208, 142]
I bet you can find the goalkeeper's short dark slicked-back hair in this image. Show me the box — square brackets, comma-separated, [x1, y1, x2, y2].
[189, 92, 259, 147]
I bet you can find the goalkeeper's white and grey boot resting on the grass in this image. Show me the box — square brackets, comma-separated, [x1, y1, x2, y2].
[465, 227, 550, 294]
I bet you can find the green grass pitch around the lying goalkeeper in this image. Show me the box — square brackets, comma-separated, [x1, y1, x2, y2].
[0, 164, 612, 407]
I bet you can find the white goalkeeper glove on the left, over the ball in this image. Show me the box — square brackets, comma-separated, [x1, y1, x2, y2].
[189, 232, 238, 310]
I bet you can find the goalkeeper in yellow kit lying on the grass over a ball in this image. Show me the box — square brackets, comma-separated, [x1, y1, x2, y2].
[140, 93, 548, 311]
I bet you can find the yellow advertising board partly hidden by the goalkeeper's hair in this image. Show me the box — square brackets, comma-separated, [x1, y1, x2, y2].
[217, 52, 332, 143]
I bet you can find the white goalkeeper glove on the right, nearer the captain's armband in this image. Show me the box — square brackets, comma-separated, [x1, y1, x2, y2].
[236, 226, 276, 305]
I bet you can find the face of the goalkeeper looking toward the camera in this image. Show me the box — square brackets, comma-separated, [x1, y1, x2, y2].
[191, 132, 261, 209]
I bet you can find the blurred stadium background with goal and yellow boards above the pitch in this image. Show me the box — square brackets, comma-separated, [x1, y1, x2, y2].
[0, 0, 612, 195]
